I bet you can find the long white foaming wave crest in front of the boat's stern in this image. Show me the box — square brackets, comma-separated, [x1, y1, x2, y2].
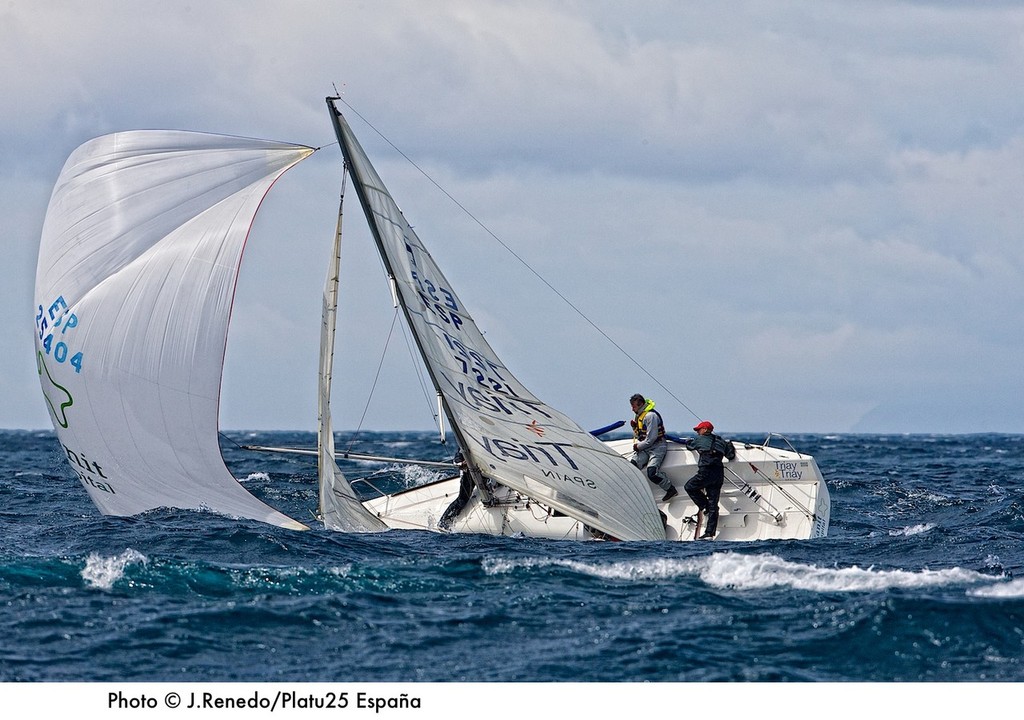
[483, 553, 992, 592]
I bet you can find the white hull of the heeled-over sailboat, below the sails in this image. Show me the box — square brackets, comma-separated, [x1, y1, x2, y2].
[364, 438, 830, 541]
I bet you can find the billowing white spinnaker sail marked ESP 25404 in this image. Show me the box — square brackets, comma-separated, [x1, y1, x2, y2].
[35, 130, 313, 530]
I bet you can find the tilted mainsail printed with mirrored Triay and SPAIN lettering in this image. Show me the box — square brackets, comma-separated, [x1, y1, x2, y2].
[328, 98, 665, 540]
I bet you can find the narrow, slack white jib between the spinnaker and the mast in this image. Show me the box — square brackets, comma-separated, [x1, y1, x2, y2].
[316, 173, 387, 533]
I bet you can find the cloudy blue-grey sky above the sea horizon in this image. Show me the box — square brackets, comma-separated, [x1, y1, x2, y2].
[0, 0, 1024, 433]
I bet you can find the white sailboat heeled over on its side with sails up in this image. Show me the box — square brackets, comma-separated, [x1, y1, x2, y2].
[35, 97, 829, 541]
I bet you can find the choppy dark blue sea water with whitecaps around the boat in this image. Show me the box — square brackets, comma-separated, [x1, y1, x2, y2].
[0, 431, 1024, 683]
